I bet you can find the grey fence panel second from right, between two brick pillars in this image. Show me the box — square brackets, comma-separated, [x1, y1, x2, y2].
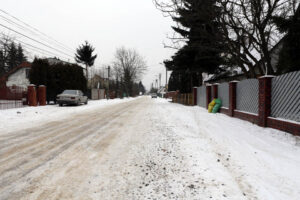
[236, 79, 259, 114]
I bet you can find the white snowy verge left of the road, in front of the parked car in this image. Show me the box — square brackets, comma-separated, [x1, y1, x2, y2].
[0, 98, 134, 135]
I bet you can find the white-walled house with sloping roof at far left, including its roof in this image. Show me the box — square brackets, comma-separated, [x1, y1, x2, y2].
[0, 62, 31, 88]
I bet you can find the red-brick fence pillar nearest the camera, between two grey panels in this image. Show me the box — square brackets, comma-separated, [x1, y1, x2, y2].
[258, 76, 274, 127]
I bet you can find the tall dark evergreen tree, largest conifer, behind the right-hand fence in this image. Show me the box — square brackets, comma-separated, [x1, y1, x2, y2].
[165, 0, 224, 92]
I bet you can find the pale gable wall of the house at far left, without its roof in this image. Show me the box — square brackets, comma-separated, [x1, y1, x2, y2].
[6, 68, 30, 88]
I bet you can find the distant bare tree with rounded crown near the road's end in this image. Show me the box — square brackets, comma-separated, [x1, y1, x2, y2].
[113, 47, 147, 95]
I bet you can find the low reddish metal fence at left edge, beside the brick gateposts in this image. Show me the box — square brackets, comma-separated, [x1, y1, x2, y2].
[0, 86, 27, 110]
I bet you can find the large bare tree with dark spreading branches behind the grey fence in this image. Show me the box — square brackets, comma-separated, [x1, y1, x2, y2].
[218, 0, 297, 77]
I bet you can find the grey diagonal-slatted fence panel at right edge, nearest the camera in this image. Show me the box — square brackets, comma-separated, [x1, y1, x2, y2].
[271, 71, 300, 122]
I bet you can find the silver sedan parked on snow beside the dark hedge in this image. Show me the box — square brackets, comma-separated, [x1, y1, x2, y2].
[56, 90, 88, 106]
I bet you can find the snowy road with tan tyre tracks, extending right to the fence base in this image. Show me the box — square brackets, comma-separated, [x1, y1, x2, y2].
[0, 97, 300, 200]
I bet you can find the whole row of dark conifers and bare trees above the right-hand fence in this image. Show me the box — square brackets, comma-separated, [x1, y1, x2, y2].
[154, 0, 300, 92]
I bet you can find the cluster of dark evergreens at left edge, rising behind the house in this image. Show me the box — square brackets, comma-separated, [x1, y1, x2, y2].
[0, 35, 27, 76]
